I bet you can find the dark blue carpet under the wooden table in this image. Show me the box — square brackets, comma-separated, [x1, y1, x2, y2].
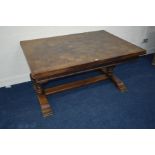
[0, 55, 155, 129]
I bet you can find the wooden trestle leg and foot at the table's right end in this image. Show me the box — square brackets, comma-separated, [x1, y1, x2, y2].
[101, 66, 127, 92]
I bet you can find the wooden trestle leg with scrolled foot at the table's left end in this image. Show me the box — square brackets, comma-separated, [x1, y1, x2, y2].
[30, 75, 53, 117]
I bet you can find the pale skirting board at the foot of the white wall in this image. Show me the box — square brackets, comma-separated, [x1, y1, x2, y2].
[0, 48, 155, 88]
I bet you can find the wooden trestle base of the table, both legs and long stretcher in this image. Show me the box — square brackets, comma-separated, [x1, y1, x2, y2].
[30, 64, 127, 117]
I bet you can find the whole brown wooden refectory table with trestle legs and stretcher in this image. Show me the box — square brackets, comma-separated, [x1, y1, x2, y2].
[20, 30, 146, 117]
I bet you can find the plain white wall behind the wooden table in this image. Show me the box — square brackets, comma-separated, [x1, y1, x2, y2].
[0, 26, 153, 87]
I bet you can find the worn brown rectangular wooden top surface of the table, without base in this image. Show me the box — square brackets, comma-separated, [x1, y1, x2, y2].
[20, 30, 145, 78]
